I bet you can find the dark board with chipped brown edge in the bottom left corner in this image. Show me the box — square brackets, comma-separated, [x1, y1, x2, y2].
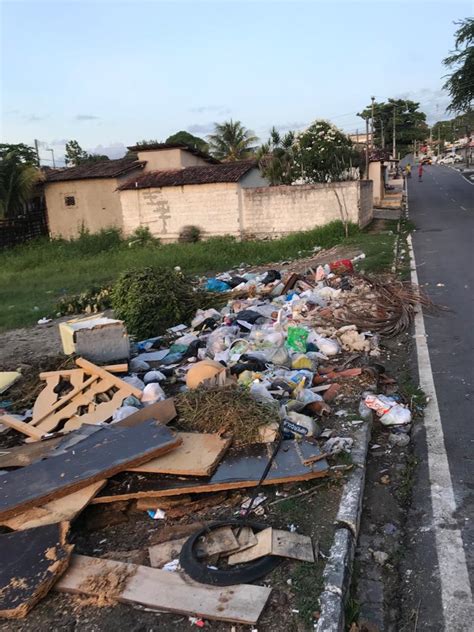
[0, 523, 73, 619]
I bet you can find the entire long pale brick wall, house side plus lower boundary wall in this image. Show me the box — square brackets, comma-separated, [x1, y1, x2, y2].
[120, 181, 373, 242]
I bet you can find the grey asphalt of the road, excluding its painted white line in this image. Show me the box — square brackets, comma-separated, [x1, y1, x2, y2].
[400, 163, 474, 632]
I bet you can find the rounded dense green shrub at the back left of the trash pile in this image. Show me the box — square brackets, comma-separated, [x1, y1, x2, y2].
[112, 267, 208, 339]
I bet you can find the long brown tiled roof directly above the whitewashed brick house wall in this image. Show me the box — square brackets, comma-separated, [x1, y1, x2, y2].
[118, 160, 257, 191]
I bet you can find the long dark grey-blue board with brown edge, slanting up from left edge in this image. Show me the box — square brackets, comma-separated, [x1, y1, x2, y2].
[0, 421, 180, 520]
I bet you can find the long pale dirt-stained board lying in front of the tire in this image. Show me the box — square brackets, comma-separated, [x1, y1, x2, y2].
[55, 555, 271, 625]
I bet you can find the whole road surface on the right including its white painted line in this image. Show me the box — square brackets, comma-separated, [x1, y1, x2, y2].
[400, 161, 474, 632]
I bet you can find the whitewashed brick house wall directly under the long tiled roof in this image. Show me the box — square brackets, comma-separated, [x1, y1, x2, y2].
[120, 183, 241, 242]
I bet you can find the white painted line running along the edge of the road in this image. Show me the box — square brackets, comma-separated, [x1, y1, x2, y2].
[407, 235, 474, 632]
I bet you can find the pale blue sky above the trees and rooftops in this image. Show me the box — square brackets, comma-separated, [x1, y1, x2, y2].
[0, 0, 472, 165]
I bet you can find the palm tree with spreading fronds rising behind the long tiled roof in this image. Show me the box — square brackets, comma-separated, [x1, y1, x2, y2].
[207, 119, 258, 162]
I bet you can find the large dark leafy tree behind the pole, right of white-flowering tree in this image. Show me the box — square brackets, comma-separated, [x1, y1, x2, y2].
[359, 99, 429, 156]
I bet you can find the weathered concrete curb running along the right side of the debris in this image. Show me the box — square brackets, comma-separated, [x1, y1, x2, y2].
[315, 422, 371, 632]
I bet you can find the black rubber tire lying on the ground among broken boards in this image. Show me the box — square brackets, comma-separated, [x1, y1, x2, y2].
[179, 520, 282, 586]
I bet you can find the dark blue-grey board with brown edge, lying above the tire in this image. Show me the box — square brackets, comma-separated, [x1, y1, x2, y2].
[92, 440, 328, 504]
